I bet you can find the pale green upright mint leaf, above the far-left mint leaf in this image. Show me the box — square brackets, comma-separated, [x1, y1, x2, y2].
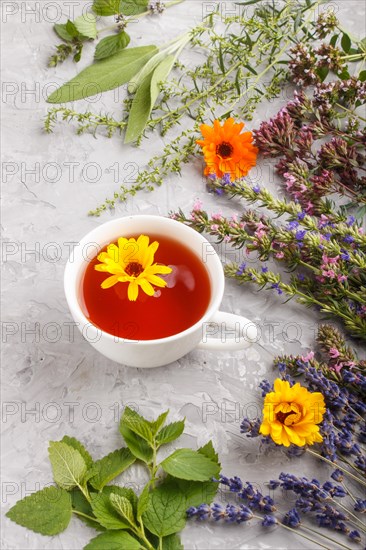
[48, 441, 87, 490]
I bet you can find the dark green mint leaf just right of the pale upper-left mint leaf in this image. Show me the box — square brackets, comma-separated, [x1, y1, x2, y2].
[89, 447, 136, 491]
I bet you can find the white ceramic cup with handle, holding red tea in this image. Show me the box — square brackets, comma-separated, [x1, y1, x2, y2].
[64, 215, 257, 368]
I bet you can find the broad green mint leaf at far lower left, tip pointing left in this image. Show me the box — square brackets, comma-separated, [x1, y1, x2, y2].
[6, 487, 72, 536]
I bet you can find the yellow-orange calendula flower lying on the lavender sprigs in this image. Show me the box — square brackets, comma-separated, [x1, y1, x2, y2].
[259, 378, 325, 447]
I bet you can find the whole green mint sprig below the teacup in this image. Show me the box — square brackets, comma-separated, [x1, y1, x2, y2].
[6, 407, 220, 550]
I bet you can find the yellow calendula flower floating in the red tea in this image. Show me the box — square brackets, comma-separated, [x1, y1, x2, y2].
[95, 235, 172, 302]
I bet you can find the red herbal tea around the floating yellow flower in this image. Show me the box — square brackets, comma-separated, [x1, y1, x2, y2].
[80, 235, 211, 340]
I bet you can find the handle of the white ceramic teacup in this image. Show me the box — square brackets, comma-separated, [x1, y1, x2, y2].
[197, 311, 258, 351]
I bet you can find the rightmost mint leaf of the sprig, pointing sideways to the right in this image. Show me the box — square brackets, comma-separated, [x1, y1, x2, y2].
[161, 449, 220, 481]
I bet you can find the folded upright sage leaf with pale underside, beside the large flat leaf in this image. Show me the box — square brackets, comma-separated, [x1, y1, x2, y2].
[124, 55, 175, 143]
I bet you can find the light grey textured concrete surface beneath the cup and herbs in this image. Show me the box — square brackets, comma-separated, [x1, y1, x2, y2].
[1, 0, 365, 550]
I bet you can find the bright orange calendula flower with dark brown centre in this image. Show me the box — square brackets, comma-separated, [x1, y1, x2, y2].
[196, 118, 258, 181]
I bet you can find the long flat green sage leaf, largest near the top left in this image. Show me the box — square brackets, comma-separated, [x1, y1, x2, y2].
[47, 46, 157, 103]
